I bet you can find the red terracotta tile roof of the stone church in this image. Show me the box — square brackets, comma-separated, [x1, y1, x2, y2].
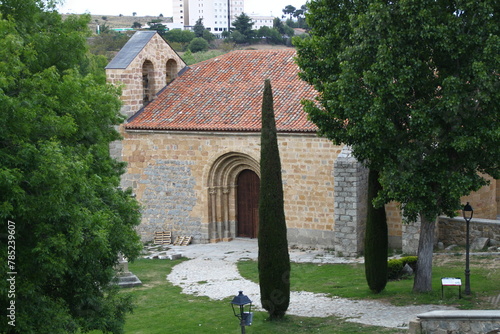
[126, 49, 317, 132]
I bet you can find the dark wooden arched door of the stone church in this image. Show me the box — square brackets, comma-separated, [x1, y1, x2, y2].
[237, 169, 260, 238]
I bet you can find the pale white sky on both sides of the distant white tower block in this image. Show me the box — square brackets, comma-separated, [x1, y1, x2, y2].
[59, 0, 306, 17]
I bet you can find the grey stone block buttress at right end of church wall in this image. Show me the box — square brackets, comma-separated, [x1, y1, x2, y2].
[334, 146, 368, 256]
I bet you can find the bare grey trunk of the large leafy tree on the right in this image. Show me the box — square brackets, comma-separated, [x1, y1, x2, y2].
[413, 215, 435, 292]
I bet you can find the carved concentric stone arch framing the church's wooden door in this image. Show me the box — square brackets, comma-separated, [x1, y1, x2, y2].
[207, 152, 260, 242]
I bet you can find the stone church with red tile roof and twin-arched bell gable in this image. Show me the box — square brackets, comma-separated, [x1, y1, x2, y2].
[106, 31, 500, 256]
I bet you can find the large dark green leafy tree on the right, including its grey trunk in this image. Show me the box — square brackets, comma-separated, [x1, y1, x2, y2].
[295, 0, 500, 292]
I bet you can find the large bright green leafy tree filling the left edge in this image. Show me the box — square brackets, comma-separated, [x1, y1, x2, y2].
[0, 0, 141, 334]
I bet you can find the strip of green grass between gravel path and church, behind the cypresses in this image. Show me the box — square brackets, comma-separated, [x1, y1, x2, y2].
[238, 254, 500, 309]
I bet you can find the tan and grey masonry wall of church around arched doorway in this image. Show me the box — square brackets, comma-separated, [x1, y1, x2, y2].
[122, 131, 340, 247]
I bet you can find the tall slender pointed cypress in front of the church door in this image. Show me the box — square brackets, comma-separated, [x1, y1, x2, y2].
[259, 80, 290, 320]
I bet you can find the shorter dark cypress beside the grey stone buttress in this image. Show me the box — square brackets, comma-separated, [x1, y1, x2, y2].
[365, 170, 388, 293]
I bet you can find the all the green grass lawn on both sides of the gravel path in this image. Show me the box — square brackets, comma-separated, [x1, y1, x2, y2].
[107, 255, 500, 334]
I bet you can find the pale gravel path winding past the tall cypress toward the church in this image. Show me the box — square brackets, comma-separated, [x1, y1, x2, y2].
[162, 239, 452, 328]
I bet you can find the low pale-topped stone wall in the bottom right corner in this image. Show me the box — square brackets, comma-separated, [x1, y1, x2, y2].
[408, 310, 500, 334]
